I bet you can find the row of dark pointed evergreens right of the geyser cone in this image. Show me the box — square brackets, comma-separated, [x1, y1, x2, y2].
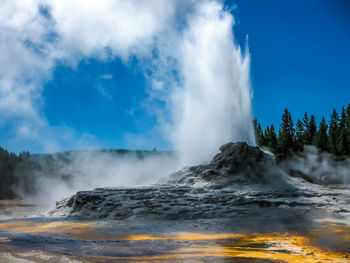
[253, 104, 350, 158]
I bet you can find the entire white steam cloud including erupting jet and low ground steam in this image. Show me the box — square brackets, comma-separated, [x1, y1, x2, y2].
[0, 0, 254, 202]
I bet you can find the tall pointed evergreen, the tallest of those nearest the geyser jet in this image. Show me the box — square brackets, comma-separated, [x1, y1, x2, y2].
[278, 109, 294, 155]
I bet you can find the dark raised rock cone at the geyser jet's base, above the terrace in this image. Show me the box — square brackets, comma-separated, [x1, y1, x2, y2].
[168, 142, 284, 188]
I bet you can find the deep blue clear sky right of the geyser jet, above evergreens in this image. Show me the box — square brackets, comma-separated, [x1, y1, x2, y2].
[234, 0, 350, 127]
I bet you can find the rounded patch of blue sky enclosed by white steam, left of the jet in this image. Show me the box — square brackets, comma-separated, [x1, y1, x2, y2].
[44, 59, 154, 151]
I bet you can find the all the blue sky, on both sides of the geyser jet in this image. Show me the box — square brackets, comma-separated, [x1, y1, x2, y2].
[0, 0, 350, 152]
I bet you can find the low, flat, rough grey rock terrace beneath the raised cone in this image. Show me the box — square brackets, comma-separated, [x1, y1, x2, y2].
[50, 184, 349, 223]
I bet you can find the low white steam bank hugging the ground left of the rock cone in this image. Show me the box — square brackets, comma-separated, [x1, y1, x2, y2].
[28, 150, 177, 204]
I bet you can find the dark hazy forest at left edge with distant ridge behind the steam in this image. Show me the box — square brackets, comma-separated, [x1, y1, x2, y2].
[0, 147, 168, 199]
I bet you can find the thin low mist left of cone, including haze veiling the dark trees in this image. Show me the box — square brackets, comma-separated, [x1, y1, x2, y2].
[12, 150, 178, 205]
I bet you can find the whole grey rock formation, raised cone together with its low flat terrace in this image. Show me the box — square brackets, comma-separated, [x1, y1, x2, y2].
[49, 143, 350, 220]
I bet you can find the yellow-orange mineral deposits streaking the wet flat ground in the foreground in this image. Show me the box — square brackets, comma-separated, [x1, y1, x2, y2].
[0, 221, 350, 263]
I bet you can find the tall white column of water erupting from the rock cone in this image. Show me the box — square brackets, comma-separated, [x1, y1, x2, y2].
[172, 1, 255, 165]
